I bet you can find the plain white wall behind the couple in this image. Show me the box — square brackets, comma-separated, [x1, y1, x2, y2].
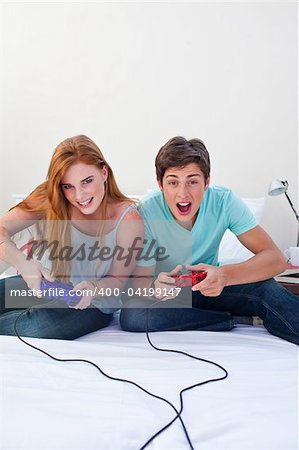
[0, 2, 298, 249]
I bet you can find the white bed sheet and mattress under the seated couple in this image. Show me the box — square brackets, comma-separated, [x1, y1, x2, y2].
[0, 321, 298, 450]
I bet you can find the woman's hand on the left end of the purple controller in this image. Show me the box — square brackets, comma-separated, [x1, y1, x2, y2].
[17, 260, 55, 292]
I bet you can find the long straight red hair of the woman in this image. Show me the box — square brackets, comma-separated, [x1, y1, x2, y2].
[12, 135, 133, 281]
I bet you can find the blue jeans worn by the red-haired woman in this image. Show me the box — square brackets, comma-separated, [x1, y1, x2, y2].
[0, 276, 113, 340]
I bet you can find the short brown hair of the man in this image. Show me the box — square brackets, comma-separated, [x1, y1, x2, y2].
[155, 136, 211, 183]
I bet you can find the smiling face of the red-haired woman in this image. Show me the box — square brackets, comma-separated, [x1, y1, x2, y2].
[60, 162, 108, 215]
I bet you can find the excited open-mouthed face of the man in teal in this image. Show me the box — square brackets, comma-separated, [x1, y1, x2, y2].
[159, 163, 210, 226]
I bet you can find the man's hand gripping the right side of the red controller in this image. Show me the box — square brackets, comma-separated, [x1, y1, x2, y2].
[186, 264, 227, 297]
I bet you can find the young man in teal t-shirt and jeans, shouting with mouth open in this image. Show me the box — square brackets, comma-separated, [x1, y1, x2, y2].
[121, 137, 299, 345]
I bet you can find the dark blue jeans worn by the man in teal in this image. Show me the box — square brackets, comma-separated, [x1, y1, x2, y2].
[120, 279, 299, 345]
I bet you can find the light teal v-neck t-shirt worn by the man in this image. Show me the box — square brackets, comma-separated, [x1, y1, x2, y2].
[138, 186, 257, 273]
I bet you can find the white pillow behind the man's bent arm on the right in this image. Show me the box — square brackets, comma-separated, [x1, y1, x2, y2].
[218, 197, 265, 264]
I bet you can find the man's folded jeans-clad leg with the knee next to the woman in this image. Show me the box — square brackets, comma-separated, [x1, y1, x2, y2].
[120, 298, 234, 332]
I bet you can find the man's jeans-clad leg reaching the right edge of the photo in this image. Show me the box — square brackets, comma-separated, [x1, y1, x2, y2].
[193, 279, 299, 345]
